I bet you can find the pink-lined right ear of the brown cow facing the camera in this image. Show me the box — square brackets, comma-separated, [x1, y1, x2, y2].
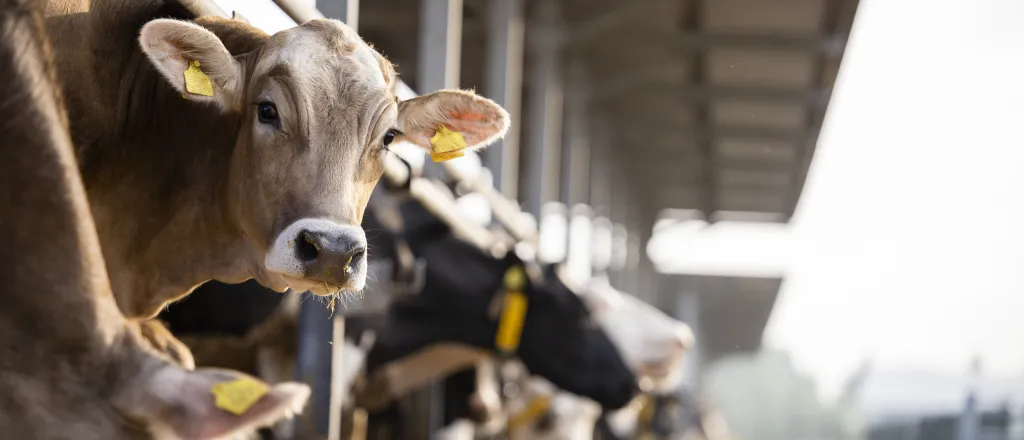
[398, 90, 511, 149]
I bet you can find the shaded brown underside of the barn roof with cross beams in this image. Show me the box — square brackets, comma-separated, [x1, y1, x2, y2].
[359, 0, 858, 221]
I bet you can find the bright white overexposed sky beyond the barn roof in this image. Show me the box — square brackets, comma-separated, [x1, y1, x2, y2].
[217, 0, 1024, 403]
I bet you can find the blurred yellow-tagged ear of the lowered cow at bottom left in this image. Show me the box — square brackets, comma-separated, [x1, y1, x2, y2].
[117, 364, 309, 439]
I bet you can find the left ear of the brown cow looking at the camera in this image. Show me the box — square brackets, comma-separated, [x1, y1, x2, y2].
[138, 18, 245, 112]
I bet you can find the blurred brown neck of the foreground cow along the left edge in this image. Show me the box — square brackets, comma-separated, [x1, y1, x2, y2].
[0, 2, 161, 433]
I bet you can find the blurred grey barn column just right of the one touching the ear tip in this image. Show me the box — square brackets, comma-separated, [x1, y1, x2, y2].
[523, 0, 563, 216]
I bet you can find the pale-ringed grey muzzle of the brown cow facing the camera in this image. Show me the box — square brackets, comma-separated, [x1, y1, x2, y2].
[265, 219, 367, 295]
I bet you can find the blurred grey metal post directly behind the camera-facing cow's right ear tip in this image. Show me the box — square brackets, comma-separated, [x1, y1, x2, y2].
[483, 0, 524, 200]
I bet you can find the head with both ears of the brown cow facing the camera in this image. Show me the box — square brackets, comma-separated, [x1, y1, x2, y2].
[139, 19, 509, 295]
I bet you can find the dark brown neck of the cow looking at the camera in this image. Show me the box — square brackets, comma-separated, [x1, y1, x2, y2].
[51, 0, 258, 317]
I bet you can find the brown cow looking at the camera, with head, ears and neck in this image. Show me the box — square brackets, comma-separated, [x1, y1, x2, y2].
[41, 0, 509, 323]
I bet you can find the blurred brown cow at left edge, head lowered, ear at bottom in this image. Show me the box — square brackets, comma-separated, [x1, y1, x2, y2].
[0, 0, 309, 440]
